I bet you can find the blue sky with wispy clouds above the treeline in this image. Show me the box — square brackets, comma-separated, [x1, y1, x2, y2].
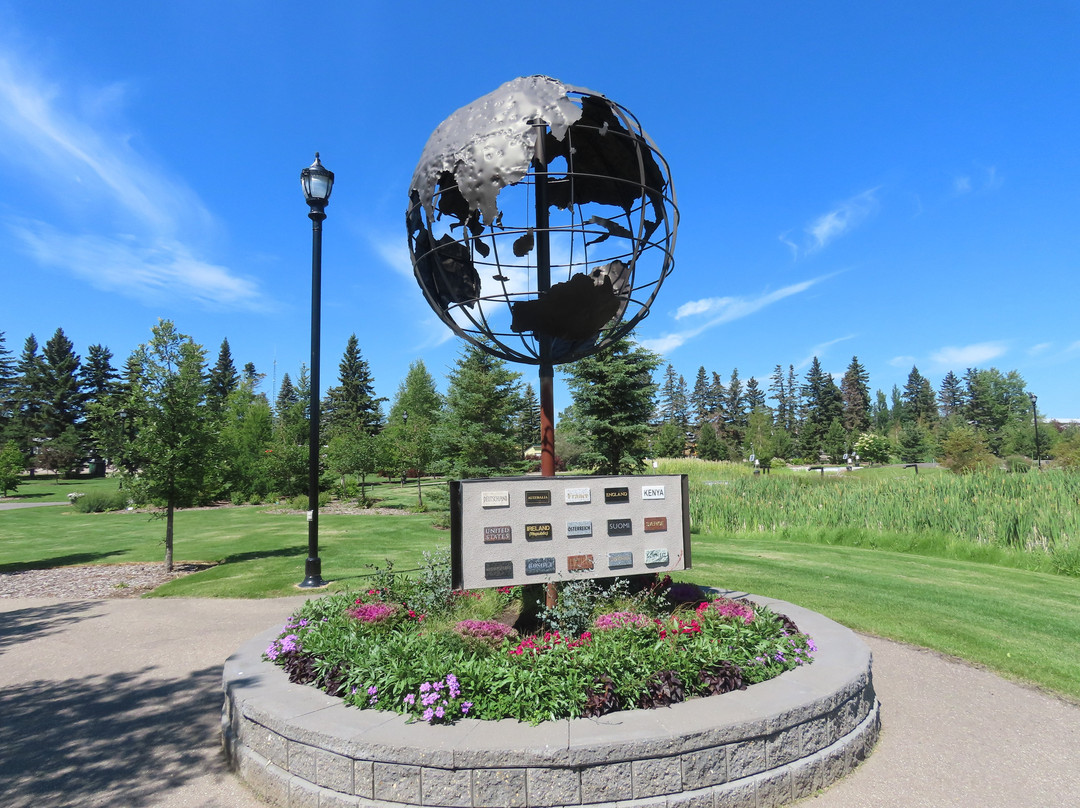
[0, 6, 1080, 418]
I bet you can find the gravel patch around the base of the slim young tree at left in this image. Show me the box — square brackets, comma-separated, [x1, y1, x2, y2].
[0, 562, 213, 601]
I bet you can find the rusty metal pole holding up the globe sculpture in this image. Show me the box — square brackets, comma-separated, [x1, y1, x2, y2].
[532, 121, 558, 608]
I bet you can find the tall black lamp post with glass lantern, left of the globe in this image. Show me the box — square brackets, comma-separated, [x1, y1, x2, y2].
[299, 151, 334, 589]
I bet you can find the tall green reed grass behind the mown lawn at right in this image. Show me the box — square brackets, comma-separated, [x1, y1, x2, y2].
[659, 460, 1080, 575]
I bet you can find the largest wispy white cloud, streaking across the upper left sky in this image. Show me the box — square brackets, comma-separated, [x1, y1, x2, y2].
[0, 44, 259, 310]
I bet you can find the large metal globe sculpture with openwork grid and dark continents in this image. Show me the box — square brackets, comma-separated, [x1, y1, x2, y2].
[406, 76, 678, 372]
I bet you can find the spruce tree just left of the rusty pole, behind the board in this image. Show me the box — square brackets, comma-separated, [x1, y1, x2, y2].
[438, 345, 521, 477]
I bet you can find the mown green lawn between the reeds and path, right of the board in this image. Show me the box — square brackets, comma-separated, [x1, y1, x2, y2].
[686, 537, 1080, 700]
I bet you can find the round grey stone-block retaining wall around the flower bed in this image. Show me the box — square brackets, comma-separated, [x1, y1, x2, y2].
[221, 597, 880, 808]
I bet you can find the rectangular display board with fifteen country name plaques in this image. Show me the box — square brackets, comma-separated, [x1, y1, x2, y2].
[450, 474, 690, 589]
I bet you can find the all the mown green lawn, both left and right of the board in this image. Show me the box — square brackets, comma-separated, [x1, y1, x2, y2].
[0, 473, 1080, 700]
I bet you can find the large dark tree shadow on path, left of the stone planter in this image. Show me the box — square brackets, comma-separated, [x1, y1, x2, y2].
[0, 661, 225, 808]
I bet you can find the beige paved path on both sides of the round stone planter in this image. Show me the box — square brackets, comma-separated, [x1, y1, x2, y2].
[0, 597, 1080, 808]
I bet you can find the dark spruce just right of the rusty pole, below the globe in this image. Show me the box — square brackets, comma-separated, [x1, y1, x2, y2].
[566, 337, 660, 474]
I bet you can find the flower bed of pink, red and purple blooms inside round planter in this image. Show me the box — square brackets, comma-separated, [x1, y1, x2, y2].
[265, 566, 815, 724]
